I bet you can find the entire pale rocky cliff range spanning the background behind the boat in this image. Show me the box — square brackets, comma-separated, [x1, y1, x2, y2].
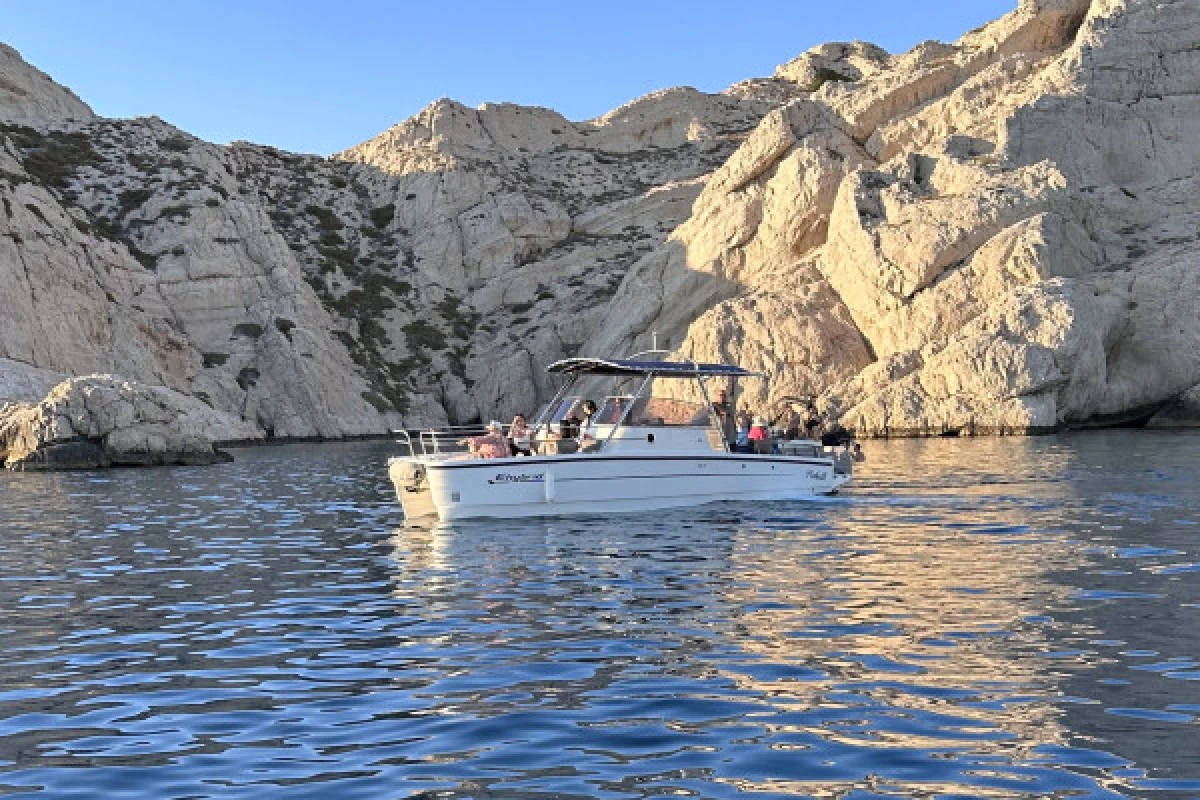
[0, 0, 1200, 462]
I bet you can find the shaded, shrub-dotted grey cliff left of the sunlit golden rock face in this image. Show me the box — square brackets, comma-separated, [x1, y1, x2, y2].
[0, 56, 794, 438]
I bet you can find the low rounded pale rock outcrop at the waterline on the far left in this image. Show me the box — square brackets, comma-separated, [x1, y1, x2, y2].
[0, 375, 259, 470]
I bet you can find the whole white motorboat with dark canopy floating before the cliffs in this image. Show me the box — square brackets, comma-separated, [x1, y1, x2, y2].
[389, 359, 852, 521]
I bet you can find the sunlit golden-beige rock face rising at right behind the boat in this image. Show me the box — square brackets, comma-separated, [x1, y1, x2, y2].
[588, 0, 1200, 435]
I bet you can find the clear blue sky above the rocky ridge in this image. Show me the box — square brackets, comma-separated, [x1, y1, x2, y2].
[7, 0, 1016, 155]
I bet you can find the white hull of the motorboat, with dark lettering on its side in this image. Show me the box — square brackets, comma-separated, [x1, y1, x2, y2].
[391, 452, 850, 521]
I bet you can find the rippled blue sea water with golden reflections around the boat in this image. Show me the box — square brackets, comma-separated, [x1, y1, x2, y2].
[0, 432, 1200, 800]
